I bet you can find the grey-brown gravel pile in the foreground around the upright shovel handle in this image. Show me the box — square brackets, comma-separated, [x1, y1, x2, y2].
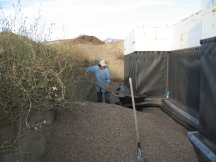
[42, 102, 197, 162]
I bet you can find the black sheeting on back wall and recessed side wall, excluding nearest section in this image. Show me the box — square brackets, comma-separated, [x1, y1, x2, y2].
[124, 48, 200, 117]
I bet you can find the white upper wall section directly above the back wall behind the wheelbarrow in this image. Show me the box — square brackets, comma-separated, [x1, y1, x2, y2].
[124, 25, 172, 55]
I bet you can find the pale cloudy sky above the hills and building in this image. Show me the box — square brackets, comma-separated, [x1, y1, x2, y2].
[0, 0, 201, 40]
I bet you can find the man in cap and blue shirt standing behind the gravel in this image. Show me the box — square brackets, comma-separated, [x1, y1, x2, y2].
[86, 60, 111, 104]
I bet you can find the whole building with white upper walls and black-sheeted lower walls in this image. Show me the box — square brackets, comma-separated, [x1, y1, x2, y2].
[120, 0, 216, 162]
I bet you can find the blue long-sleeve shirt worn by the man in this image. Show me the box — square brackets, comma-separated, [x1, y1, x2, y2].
[86, 66, 111, 92]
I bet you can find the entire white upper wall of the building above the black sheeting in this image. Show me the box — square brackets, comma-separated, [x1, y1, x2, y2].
[125, 0, 216, 55]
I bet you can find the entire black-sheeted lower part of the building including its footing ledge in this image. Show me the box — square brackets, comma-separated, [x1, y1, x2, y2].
[124, 37, 216, 161]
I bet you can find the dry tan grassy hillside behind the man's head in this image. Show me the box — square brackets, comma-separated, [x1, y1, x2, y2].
[48, 37, 124, 81]
